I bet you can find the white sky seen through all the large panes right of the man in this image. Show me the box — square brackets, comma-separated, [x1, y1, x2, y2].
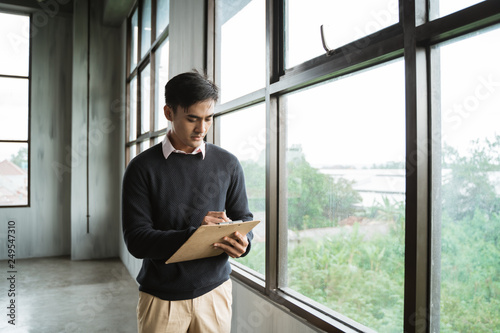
[217, 0, 494, 167]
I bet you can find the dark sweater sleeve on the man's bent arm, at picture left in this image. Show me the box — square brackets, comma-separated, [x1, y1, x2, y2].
[122, 161, 196, 259]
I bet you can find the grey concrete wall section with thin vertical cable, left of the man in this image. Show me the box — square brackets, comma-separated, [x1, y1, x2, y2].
[71, 0, 125, 259]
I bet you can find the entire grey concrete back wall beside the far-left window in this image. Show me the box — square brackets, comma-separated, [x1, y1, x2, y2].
[0, 0, 125, 259]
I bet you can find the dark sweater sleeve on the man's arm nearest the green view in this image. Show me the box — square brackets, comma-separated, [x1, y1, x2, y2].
[226, 158, 253, 257]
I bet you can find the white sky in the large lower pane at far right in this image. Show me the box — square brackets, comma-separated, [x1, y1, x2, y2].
[439, 27, 500, 154]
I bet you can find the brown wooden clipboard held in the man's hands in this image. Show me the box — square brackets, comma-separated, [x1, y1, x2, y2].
[165, 221, 260, 264]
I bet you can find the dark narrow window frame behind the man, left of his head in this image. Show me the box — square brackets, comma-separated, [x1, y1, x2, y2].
[125, 0, 170, 164]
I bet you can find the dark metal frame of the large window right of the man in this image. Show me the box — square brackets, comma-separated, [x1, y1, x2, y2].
[207, 0, 500, 333]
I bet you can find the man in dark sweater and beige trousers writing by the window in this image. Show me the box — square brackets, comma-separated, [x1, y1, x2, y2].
[122, 73, 253, 333]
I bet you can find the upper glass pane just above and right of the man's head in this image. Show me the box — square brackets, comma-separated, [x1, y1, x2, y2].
[216, 0, 266, 103]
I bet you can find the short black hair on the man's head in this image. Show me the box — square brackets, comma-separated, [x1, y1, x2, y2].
[165, 72, 219, 112]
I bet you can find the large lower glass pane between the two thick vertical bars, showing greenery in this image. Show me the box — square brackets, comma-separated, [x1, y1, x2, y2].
[283, 61, 405, 332]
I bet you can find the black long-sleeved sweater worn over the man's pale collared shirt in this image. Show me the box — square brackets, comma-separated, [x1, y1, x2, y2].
[122, 143, 253, 300]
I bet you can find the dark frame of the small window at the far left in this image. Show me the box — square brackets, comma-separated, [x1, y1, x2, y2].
[0, 9, 33, 208]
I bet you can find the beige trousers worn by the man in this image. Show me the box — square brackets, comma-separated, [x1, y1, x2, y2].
[137, 279, 232, 333]
